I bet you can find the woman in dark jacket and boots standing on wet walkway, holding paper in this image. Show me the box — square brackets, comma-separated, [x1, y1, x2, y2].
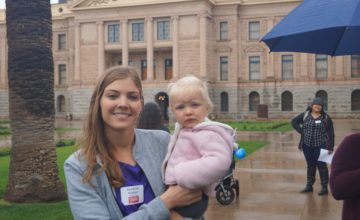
[291, 98, 334, 196]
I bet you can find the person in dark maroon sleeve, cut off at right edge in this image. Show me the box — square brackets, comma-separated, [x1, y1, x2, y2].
[330, 133, 360, 220]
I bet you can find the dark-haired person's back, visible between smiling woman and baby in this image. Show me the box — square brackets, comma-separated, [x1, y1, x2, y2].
[137, 102, 170, 132]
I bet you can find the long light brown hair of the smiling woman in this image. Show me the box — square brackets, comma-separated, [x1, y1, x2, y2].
[79, 66, 144, 187]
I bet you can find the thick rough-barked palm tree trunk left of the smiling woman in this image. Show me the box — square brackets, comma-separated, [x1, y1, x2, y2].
[4, 0, 66, 202]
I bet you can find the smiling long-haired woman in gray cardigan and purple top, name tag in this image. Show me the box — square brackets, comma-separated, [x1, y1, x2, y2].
[64, 67, 202, 220]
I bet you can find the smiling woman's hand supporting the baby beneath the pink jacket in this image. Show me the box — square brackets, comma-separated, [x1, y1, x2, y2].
[160, 185, 202, 209]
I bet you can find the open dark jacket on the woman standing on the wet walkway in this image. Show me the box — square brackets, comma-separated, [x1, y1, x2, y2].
[291, 108, 335, 151]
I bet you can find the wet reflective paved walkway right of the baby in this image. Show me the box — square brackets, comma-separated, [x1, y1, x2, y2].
[205, 120, 360, 220]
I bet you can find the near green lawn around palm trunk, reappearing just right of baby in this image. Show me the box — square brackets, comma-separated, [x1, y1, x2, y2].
[0, 141, 267, 220]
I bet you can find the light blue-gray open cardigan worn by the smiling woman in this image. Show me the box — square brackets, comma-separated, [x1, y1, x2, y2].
[64, 129, 170, 220]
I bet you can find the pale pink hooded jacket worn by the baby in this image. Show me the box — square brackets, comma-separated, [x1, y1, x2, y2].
[162, 119, 235, 197]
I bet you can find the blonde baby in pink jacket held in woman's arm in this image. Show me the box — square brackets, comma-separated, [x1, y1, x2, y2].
[162, 76, 234, 218]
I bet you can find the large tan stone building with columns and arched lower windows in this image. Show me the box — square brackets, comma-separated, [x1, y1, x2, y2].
[0, 0, 360, 119]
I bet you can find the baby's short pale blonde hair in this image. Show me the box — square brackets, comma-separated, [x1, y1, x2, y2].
[168, 75, 213, 113]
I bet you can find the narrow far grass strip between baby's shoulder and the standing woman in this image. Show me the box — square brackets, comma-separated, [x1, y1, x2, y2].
[223, 121, 293, 132]
